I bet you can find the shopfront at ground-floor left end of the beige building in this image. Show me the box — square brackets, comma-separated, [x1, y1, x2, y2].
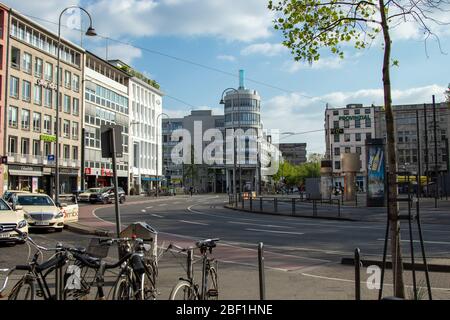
[8, 165, 43, 192]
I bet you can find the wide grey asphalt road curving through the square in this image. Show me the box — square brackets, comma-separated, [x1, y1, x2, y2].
[0, 195, 450, 299]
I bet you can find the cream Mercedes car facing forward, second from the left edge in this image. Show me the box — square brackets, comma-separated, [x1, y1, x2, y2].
[15, 193, 64, 232]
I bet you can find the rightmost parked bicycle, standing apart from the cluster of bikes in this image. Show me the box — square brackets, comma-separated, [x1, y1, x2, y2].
[166, 239, 220, 300]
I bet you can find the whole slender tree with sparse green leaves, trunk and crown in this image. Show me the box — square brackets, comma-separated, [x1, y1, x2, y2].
[268, 0, 449, 298]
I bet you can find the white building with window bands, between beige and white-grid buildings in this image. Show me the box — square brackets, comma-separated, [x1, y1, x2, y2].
[83, 52, 130, 192]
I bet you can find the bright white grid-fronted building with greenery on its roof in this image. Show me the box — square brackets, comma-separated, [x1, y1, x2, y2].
[109, 60, 163, 194]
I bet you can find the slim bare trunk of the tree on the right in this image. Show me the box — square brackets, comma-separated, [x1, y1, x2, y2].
[379, 0, 405, 298]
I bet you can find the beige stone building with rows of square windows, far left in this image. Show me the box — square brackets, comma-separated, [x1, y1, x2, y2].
[4, 9, 84, 194]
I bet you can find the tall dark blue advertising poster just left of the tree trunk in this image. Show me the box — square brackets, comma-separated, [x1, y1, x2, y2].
[366, 139, 385, 207]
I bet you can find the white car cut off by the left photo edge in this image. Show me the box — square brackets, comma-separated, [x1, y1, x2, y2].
[0, 199, 28, 243]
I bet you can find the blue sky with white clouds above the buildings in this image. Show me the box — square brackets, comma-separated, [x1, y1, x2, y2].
[6, 0, 450, 153]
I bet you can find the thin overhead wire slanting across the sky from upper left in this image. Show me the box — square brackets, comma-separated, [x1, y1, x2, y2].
[22, 13, 331, 105]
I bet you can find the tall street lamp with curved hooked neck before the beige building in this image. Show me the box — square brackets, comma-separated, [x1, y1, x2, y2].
[55, 5, 97, 203]
